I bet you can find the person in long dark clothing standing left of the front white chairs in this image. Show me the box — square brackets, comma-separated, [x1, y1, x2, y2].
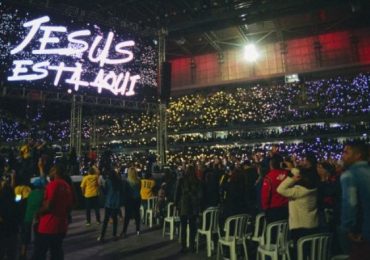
[175, 166, 203, 253]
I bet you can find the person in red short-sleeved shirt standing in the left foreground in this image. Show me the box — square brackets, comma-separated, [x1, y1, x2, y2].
[33, 165, 73, 260]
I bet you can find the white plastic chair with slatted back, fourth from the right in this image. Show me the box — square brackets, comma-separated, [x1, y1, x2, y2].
[217, 214, 251, 260]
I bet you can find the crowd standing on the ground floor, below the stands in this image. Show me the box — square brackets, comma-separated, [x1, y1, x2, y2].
[0, 140, 370, 259]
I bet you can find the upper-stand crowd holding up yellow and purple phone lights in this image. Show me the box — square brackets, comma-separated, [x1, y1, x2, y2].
[0, 74, 370, 142]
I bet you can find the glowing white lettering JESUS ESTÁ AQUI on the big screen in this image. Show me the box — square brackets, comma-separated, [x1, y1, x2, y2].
[8, 16, 140, 96]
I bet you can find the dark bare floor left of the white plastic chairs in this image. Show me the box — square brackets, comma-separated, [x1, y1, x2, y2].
[64, 210, 216, 260]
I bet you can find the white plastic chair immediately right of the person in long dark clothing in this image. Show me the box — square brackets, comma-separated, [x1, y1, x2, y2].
[196, 207, 219, 257]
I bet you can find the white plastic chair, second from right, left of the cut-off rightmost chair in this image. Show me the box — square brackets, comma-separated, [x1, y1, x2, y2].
[257, 220, 290, 260]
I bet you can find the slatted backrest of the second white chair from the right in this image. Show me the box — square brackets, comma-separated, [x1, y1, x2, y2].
[261, 220, 288, 250]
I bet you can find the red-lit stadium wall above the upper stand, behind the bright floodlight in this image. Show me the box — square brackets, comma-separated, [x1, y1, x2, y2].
[171, 28, 370, 92]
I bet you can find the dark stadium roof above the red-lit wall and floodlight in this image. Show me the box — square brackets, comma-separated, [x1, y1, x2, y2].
[44, 0, 370, 58]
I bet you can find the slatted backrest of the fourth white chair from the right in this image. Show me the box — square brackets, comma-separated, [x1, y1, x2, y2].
[224, 214, 251, 239]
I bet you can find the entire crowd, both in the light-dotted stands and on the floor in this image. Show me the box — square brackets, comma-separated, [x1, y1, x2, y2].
[0, 71, 370, 260]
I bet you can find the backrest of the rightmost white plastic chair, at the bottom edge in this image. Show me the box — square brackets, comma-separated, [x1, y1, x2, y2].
[297, 233, 331, 260]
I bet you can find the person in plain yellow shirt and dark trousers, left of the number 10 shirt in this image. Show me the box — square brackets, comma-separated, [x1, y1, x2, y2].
[81, 166, 100, 226]
